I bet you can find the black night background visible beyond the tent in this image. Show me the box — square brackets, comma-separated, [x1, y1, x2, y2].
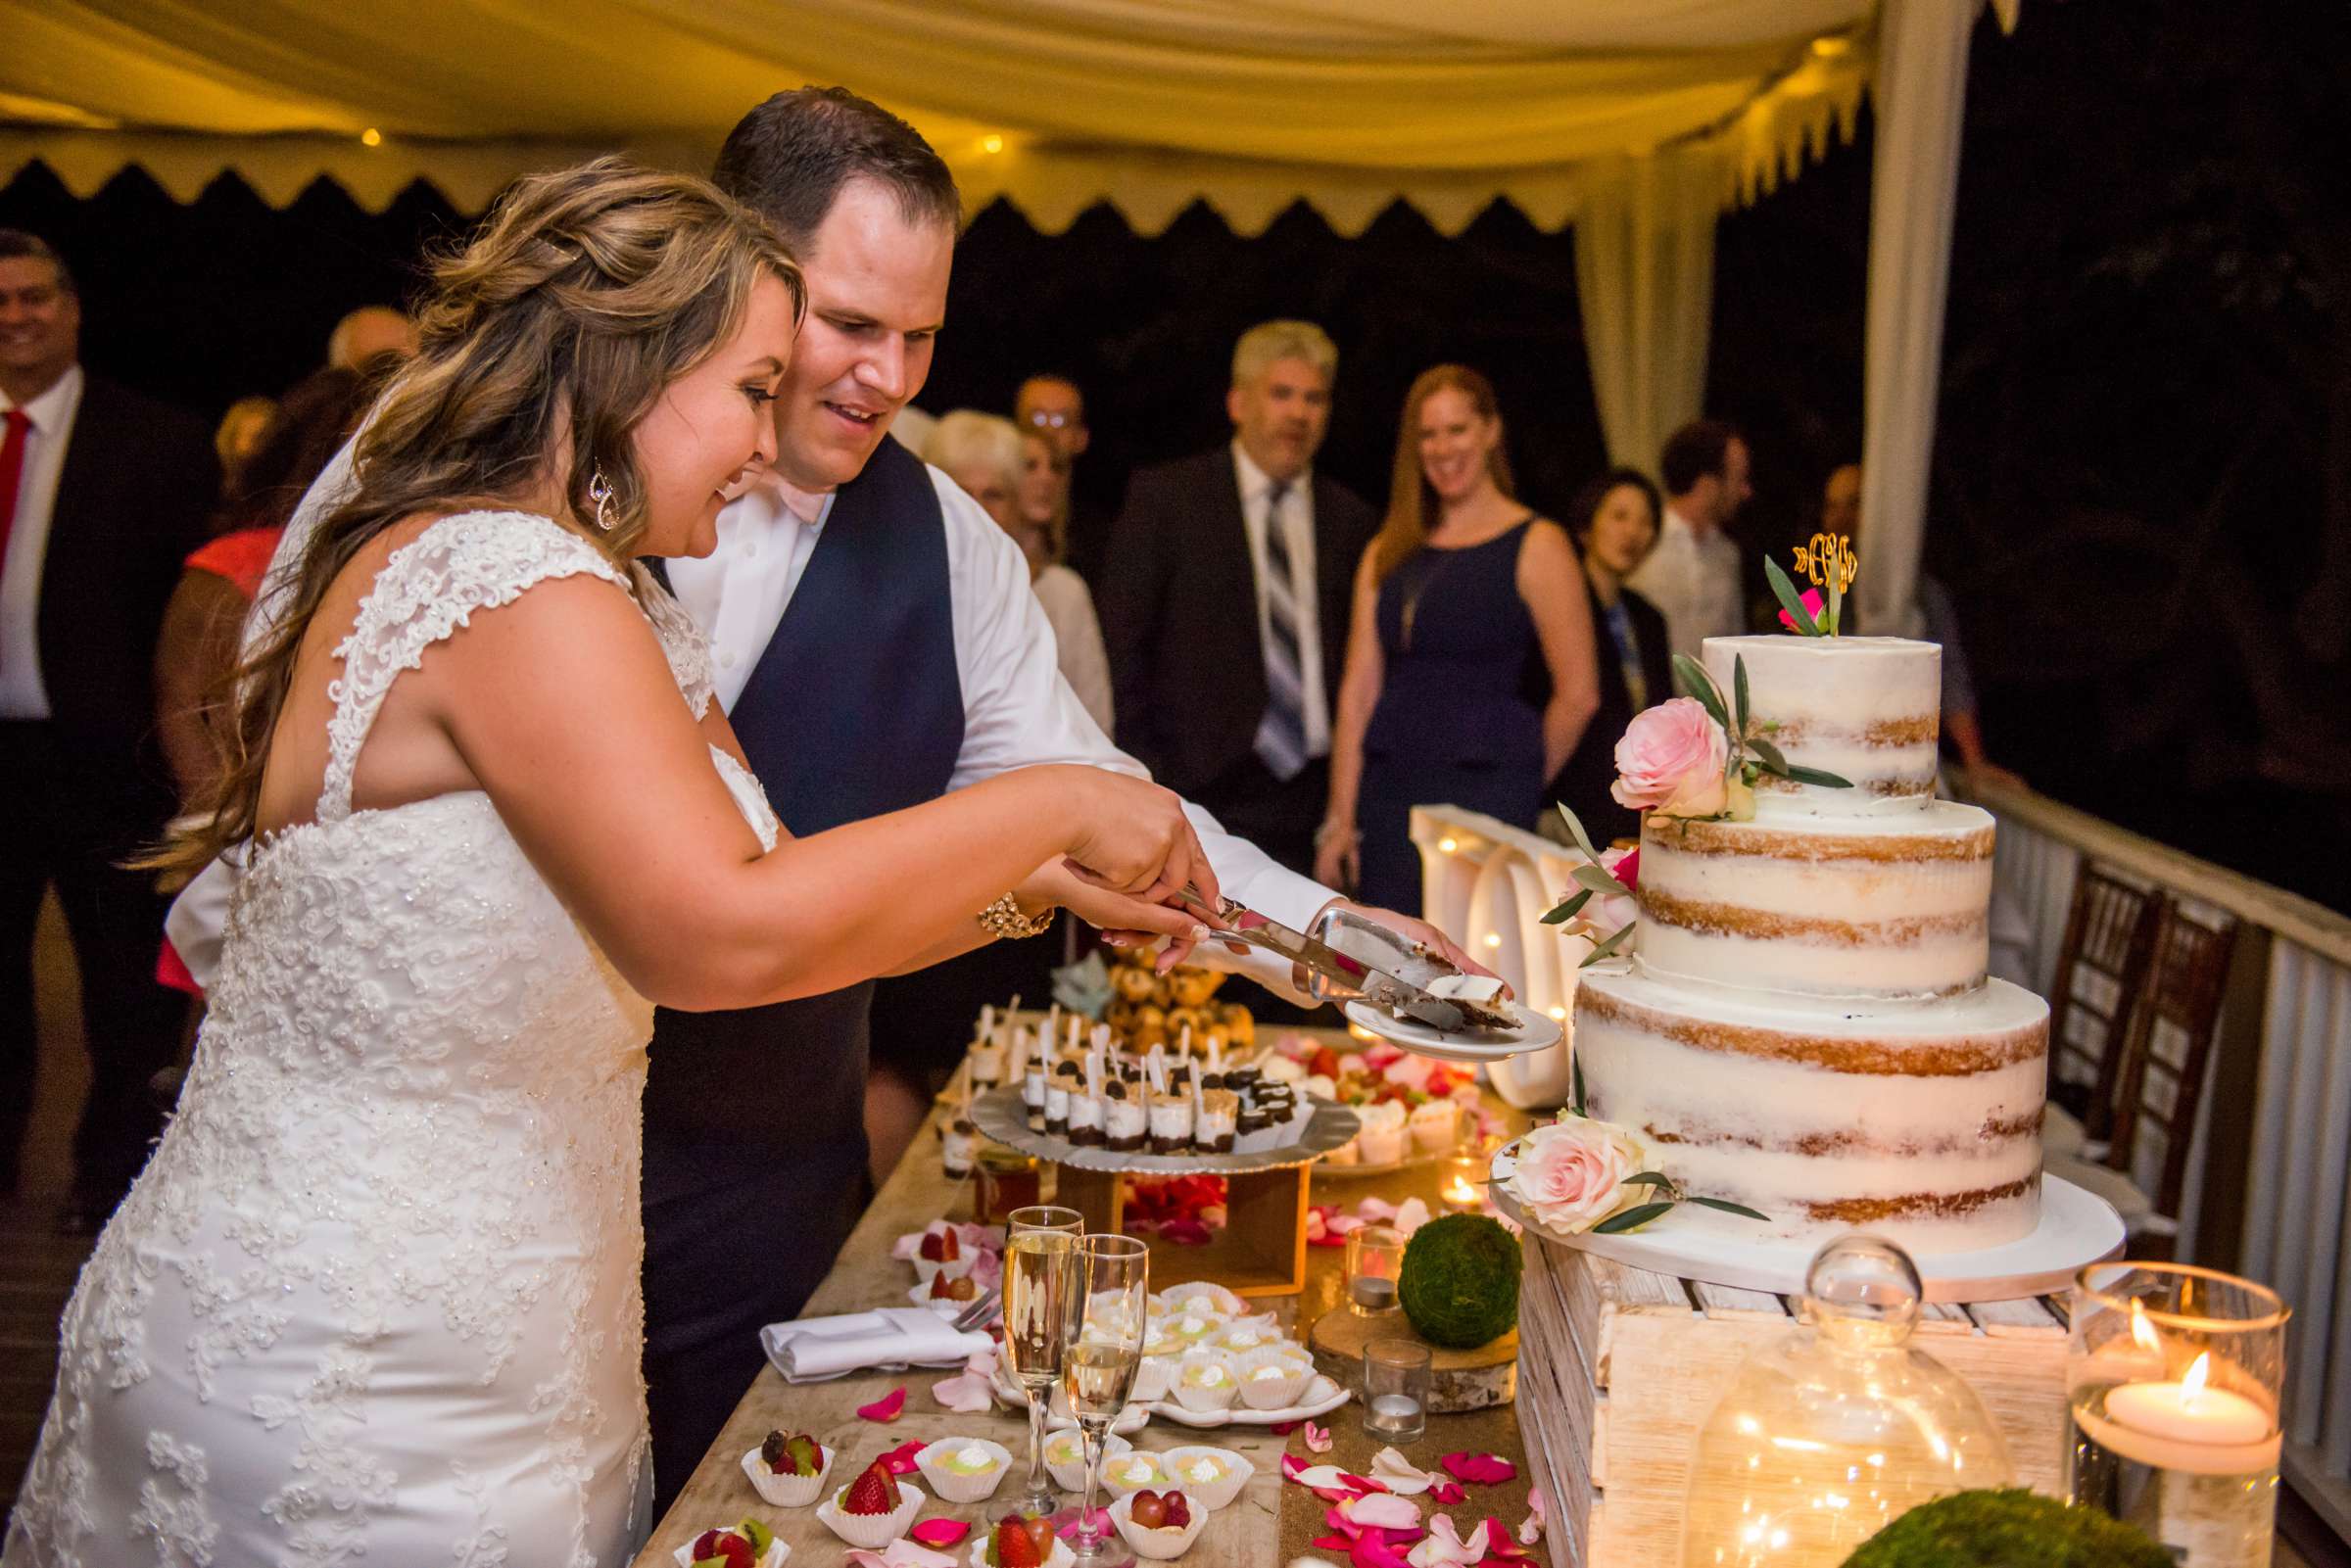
[0, 0, 2351, 908]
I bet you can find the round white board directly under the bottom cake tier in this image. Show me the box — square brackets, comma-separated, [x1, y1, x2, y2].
[1491, 1143, 2123, 1303]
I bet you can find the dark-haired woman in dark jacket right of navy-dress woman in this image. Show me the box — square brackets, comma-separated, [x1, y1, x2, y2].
[1535, 468, 1674, 849]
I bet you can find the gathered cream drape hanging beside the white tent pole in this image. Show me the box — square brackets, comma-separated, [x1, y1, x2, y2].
[1575, 143, 1723, 472]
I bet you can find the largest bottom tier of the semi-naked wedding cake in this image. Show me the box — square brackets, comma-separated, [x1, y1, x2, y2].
[1575, 964, 2047, 1253]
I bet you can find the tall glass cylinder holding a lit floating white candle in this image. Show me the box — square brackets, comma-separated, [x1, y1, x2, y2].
[2067, 1262, 2292, 1568]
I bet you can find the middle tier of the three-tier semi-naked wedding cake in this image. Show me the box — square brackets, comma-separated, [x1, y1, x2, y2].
[1639, 799, 1993, 997]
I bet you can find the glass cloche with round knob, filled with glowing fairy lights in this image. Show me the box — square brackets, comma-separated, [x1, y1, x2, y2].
[1681, 1234, 2012, 1568]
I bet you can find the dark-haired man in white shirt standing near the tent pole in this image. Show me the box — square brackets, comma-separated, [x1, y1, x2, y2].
[1629, 418, 1753, 658]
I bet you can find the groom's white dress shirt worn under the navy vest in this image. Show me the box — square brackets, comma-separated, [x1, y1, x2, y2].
[165, 447, 1335, 994]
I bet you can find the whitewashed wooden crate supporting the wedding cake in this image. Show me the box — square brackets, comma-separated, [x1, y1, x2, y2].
[1518, 1232, 2067, 1568]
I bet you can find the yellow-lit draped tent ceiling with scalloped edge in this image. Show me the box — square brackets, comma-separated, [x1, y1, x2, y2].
[0, 0, 1871, 233]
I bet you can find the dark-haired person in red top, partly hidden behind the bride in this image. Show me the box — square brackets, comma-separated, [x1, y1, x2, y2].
[155, 369, 366, 802]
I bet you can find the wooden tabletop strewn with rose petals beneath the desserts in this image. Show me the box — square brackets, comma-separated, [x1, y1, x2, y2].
[635, 1048, 1528, 1568]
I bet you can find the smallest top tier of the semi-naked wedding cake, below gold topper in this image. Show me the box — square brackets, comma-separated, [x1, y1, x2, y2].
[1704, 637, 1942, 818]
